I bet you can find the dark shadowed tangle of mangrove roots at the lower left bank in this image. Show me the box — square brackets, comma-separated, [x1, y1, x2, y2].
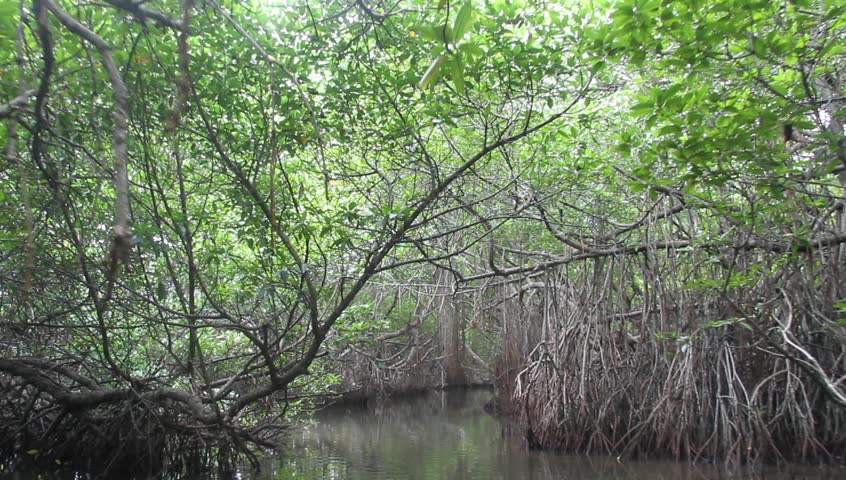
[0, 376, 272, 478]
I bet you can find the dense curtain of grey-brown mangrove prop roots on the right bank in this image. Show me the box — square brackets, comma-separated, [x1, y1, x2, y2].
[497, 255, 846, 464]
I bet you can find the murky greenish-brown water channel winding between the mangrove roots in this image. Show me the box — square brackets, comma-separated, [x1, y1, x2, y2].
[255, 389, 846, 480]
